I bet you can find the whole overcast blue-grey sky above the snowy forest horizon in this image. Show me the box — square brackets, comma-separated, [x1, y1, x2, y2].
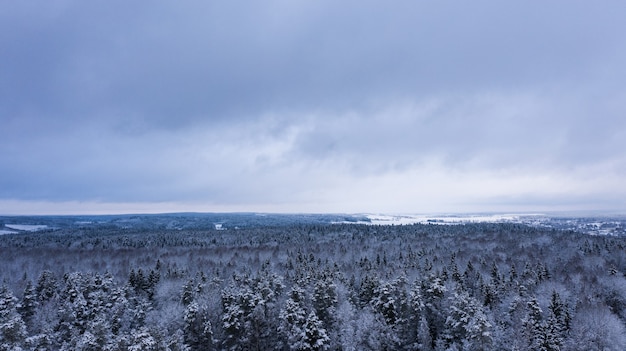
[0, 0, 626, 214]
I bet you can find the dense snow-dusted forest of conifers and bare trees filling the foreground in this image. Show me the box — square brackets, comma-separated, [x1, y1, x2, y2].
[0, 223, 626, 350]
